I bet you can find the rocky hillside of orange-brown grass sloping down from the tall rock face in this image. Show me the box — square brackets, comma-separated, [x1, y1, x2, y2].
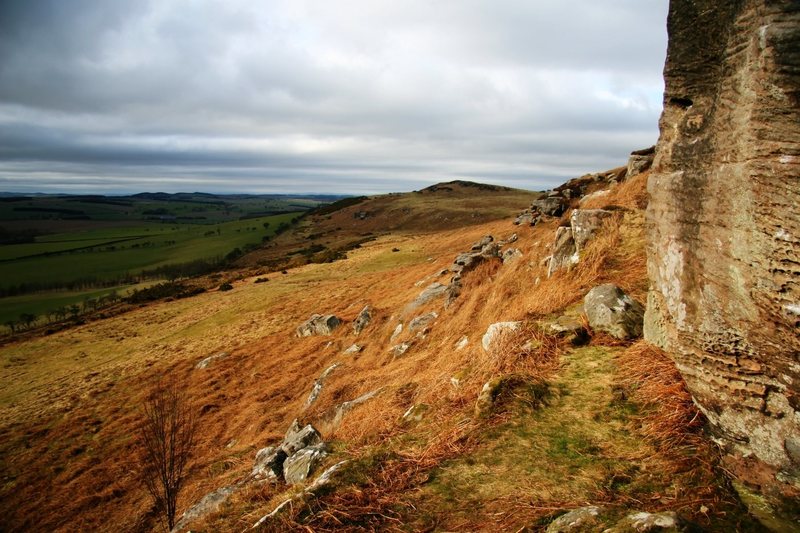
[0, 170, 756, 531]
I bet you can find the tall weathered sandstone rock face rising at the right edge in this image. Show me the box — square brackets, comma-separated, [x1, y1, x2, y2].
[645, 0, 800, 526]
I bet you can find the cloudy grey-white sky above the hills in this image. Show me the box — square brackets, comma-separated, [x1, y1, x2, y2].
[0, 0, 667, 194]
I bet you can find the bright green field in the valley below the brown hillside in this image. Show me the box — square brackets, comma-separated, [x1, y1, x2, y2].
[0, 212, 300, 324]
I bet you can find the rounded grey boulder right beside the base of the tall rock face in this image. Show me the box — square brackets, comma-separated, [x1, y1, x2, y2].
[583, 283, 644, 339]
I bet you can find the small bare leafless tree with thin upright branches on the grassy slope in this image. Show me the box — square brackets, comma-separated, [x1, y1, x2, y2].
[139, 382, 196, 530]
